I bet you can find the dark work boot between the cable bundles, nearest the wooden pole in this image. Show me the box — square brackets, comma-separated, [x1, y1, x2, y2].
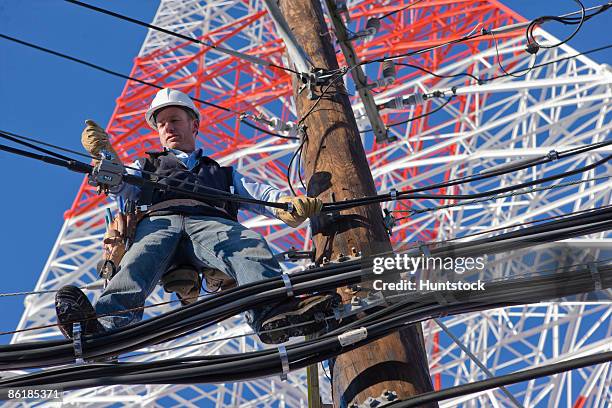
[257, 292, 341, 344]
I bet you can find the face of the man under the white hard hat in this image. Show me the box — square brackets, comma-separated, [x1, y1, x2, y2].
[156, 106, 200, 153]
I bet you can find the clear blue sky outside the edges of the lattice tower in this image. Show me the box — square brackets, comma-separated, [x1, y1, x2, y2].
[0, 0, 612, 343]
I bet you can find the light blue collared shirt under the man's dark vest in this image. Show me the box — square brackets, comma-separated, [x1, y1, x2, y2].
[110, 149, 283, 217]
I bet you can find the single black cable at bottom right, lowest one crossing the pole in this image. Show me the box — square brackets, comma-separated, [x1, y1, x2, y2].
[388, 351, 612, 408]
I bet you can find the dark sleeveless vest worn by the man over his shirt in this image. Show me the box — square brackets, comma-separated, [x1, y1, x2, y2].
[138, 151, 238, 221]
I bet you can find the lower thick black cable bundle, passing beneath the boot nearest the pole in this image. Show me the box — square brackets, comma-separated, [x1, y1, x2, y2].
[0, 258, 612, 390]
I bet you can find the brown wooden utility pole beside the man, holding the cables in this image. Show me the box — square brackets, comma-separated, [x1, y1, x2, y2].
[279, 0, 437, 407]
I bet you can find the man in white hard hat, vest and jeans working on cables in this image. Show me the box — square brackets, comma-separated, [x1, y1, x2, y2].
[56, 89, 338, 344]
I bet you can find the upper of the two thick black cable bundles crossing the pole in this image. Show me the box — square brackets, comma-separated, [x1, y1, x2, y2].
[0, 209, 612, 369]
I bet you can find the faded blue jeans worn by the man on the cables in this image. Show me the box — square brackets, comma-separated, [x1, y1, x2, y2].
[95, 214, 281, 330]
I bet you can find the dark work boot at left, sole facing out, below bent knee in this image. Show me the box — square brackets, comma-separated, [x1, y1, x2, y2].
[55, 285, 105, 340]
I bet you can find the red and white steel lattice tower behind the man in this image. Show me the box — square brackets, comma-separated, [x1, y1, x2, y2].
[12, 0, 612, 407]
